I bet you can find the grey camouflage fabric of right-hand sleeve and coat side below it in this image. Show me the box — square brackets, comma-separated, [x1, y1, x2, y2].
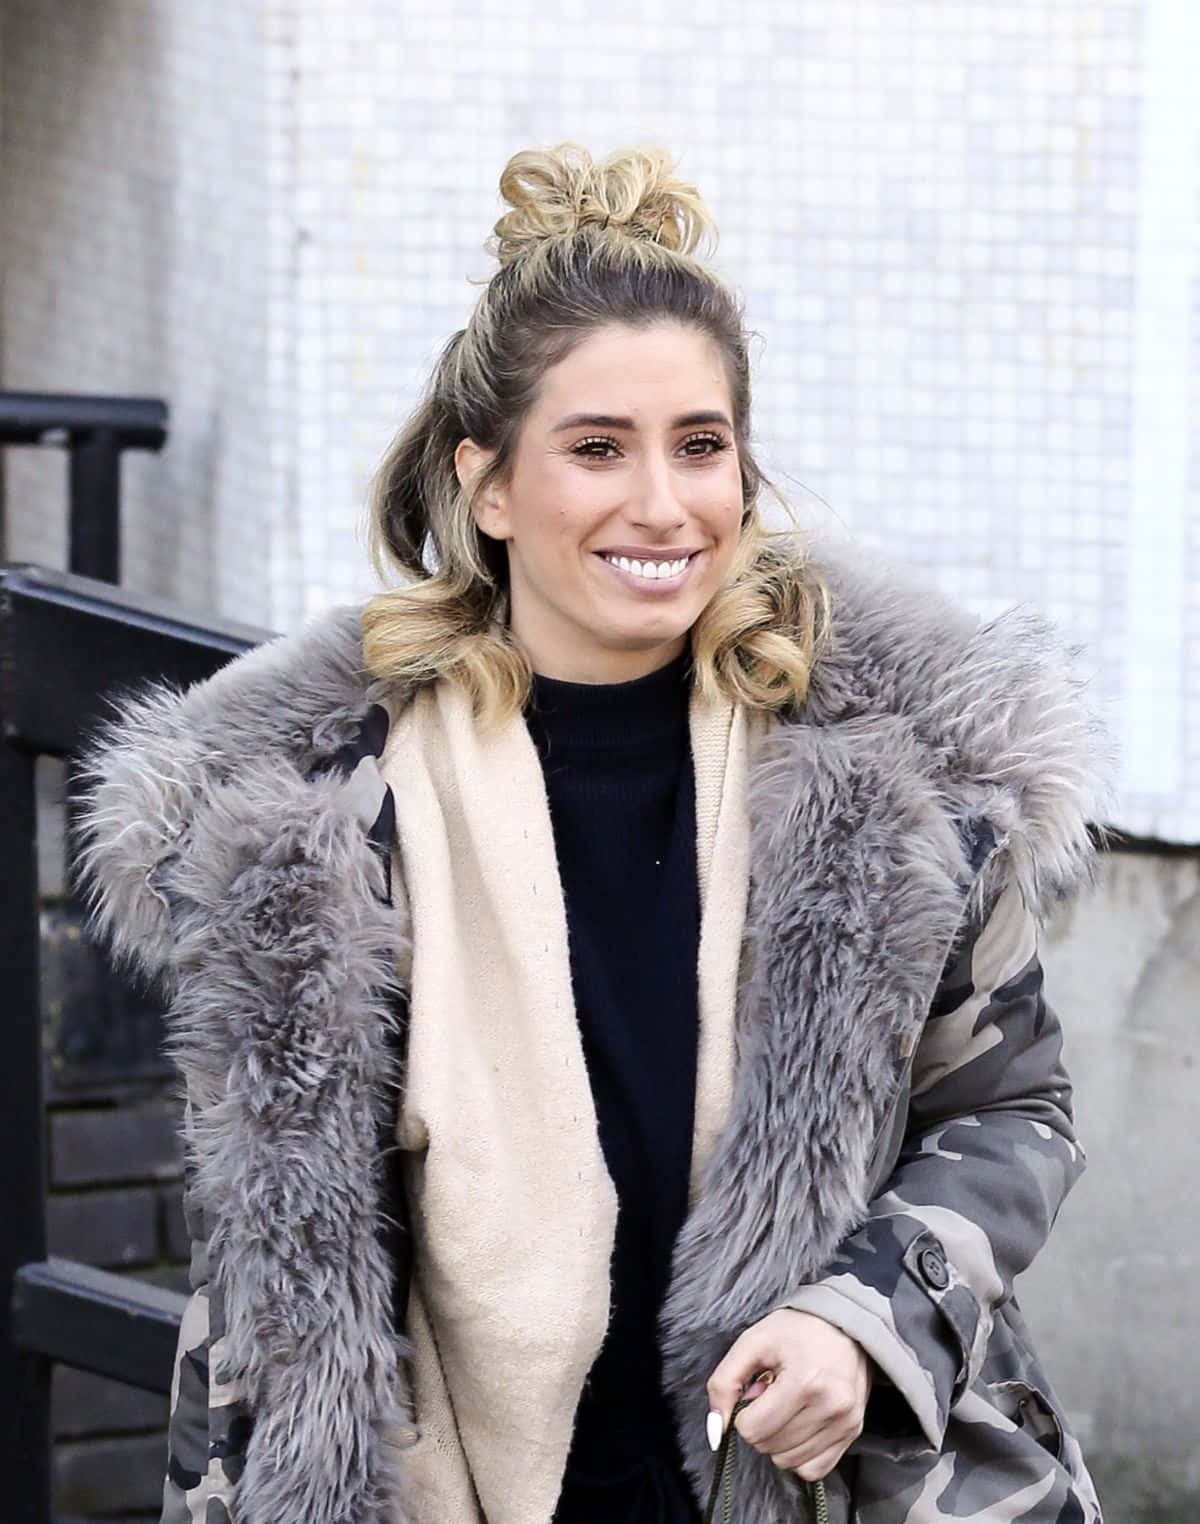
[787, 887, 1101, 1524]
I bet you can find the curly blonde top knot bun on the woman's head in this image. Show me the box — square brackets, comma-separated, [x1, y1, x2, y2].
[488, 143, 715, 265]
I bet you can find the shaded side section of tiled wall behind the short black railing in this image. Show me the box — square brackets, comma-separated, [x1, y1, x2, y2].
[0, 0, 274, 623]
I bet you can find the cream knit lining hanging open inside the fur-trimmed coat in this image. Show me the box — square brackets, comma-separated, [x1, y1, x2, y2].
[381, 683, 752, 1524]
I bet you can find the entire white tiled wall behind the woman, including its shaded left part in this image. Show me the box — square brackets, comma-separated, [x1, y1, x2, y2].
[0, 0, 1200, 841]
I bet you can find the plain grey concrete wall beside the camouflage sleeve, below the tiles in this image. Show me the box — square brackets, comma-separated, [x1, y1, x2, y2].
[1017, 853, 1200, 1524]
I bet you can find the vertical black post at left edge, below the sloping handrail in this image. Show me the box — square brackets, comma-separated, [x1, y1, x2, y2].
[0, 725, 50, 1524]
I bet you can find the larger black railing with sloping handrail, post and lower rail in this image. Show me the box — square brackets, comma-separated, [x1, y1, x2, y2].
[0, 565, 265, 1524]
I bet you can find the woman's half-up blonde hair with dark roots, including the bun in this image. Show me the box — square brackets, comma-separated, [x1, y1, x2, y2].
[361, 143, 826, 724]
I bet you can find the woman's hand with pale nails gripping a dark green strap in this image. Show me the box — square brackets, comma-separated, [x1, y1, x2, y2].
[707, 1308, 871, 1481]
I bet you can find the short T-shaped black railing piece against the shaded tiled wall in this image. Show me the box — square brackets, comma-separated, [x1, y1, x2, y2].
[0, 392, 166, 582]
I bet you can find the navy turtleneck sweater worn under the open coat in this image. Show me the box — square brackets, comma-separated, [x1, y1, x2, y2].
[526, 652, 700, 1524]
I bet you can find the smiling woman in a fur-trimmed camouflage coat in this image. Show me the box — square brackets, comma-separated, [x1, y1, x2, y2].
[75, 146, 1099, 1524]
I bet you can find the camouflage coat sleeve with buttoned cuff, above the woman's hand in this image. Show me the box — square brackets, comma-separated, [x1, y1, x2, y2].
[774, 885, 1084, 1449]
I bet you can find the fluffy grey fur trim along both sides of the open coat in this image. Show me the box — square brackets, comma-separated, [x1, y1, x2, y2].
[72, 556, 1104, 1524]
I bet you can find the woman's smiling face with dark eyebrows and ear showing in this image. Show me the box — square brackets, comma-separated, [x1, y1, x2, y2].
[456, 323, 743, 683]
